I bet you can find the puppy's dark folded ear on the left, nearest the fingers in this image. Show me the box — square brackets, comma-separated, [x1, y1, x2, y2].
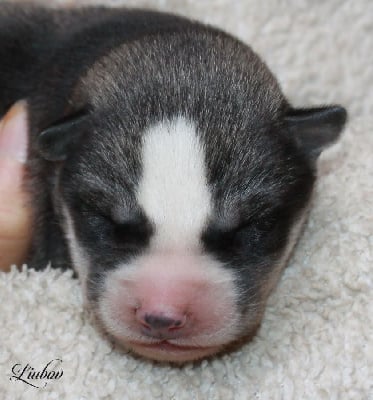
[37, 112, 88, 161]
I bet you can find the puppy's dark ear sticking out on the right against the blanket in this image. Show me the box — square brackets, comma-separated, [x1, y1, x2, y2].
[285, 106, 347, 160]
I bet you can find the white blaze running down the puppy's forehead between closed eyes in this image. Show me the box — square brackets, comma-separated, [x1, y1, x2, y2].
[137, 117, 211, 249]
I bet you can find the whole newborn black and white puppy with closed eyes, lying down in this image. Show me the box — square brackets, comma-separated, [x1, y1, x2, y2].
[0, 4, 346, 362]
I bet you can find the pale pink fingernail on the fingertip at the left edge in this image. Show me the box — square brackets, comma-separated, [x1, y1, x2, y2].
[0, 101, 28, 163]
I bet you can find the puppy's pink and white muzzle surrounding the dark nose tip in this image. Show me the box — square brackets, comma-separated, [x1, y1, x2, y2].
[94, 254, 241, 347]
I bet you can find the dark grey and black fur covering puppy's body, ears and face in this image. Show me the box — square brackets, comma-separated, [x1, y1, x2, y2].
[0, 5, 346, 352]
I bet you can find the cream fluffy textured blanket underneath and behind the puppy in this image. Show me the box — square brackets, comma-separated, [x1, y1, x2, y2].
[0, 0, 373, 400]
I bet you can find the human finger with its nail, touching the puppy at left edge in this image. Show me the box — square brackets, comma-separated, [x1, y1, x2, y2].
[0, 101, 31, 271]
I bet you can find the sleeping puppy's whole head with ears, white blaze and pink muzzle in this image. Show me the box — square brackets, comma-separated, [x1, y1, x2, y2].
[39, 31, 346, 362]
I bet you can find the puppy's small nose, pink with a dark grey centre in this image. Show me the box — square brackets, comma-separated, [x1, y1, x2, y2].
[136, 308, 187, 339]
